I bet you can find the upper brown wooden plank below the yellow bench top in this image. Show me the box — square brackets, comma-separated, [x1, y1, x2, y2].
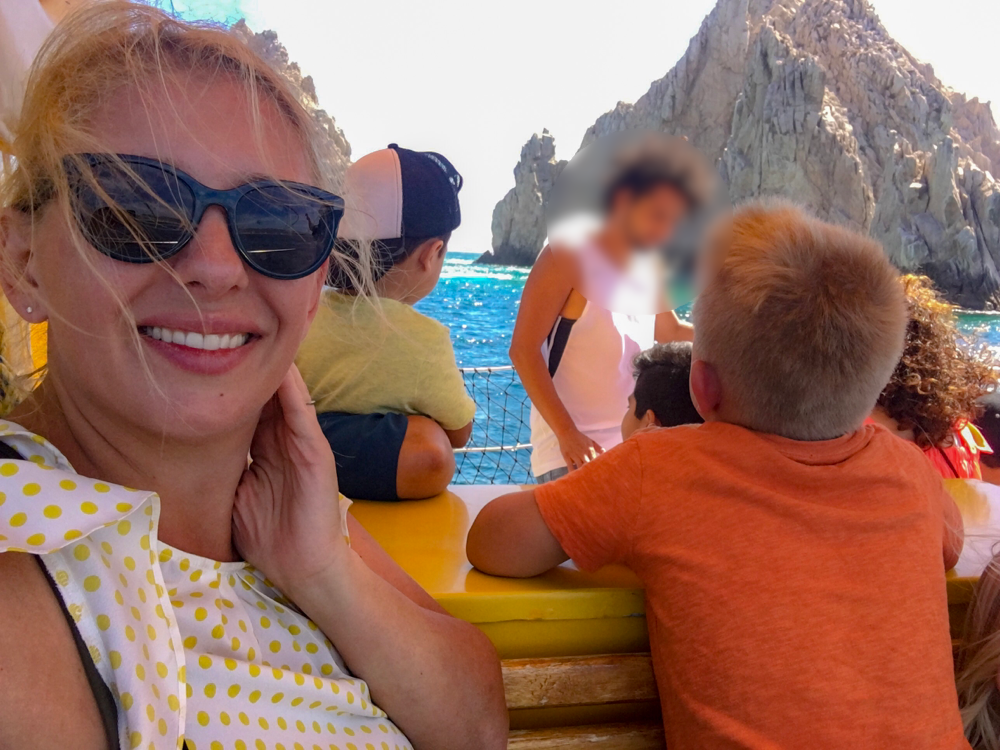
[503, 654, 657, 709]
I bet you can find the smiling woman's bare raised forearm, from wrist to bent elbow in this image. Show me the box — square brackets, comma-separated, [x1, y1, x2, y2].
[286, 552, 507, 750]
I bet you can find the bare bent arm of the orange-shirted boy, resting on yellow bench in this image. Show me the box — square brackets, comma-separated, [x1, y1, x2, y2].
[466, 490, 569, 578]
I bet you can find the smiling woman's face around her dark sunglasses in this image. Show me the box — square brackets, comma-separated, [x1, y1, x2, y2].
[26, 76, 326, 442]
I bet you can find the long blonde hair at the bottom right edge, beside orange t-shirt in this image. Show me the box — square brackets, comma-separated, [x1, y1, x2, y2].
[955, 555, 1000, 750]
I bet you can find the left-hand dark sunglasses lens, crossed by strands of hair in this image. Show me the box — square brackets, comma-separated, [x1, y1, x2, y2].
[71, 162, 195, 263]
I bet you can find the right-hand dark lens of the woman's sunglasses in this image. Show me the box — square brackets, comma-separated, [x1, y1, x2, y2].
[233, 185, 343, 279]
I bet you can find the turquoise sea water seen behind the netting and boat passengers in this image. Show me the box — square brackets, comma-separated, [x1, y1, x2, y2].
[417, 251, 1000, 483]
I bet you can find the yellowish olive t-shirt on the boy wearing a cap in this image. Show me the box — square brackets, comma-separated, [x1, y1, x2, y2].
[295, 289, 476, 430]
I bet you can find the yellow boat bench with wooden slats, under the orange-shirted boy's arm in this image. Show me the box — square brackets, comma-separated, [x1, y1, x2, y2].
[351, 482, 1000, 750]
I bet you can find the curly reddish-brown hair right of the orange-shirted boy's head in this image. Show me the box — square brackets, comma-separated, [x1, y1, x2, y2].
[878, 275, 997, 449]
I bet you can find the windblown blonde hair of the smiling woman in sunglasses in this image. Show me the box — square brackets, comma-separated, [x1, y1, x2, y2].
[0, 0, 371, 407]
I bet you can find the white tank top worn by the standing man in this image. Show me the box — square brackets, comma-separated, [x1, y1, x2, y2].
[531, 244, 662, 476]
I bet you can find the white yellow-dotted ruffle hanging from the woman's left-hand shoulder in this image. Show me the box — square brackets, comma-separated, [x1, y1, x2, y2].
[0, 420, 187, 750]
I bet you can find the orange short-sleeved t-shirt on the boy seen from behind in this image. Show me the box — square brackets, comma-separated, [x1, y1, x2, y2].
[535, 422, 969, 750]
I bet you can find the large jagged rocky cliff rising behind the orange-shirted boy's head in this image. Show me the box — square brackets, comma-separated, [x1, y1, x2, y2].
[480, 0, 1000, 307]
